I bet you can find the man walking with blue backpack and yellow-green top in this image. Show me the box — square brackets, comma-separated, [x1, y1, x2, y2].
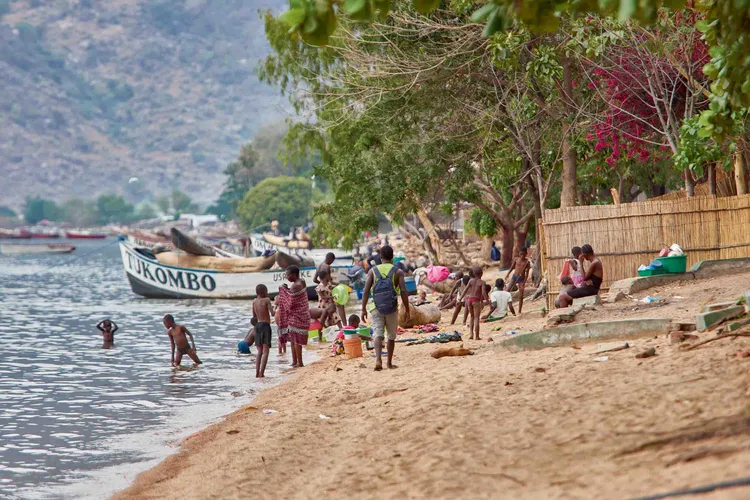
[362, 245, 409, 371]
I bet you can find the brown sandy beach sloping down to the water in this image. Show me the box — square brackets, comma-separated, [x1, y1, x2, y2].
[114, 273, 750, 499]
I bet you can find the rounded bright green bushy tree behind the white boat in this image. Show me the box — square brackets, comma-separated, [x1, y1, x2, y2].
[237, 176, 313, 231]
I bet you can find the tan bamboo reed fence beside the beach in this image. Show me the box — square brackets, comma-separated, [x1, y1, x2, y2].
[540, 195, 750, 307]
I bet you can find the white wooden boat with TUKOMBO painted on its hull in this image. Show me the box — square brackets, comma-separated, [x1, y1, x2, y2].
[120, 242, 356, 299]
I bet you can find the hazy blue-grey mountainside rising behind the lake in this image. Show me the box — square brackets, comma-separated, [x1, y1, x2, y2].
[0, 0, 285, 207]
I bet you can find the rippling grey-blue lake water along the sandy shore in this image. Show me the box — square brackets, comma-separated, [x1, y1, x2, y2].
[0, 239, 312, 499]
